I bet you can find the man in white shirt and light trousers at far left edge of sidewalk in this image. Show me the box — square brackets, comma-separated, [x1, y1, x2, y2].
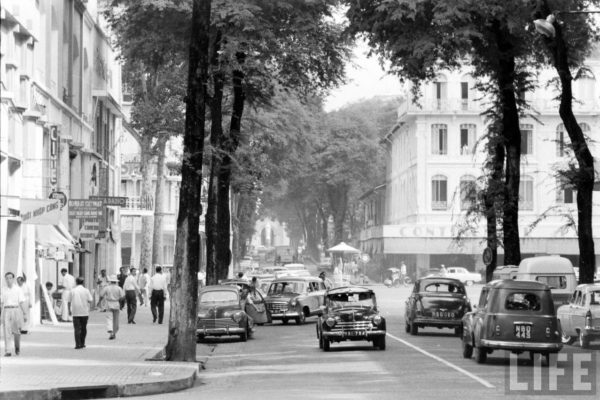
[0, 272, 28, 357]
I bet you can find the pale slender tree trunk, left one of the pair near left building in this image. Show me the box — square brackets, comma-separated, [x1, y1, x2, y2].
[139, 135, 154, 271]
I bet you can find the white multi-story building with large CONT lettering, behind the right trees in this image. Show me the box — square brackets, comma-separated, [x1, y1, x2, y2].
[360, 49, 600, 275]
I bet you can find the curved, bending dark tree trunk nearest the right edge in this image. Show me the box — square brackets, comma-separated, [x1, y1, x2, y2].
[546, 12, 596, 283]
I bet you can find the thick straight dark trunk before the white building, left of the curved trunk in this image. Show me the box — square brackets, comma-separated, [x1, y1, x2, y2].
[496, 23, 521, 265]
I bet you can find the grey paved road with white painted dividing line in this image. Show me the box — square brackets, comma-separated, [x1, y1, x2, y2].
[127, 285, 599, 400]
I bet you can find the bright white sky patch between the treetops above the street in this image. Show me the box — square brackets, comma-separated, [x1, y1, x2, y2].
[325, 41, 402, 112]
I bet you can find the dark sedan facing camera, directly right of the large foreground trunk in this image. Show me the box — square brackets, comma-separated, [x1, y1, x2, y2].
[196, 285, 253, 342]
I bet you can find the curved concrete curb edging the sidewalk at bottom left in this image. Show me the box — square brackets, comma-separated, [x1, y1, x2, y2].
[0, 367, 199, 400]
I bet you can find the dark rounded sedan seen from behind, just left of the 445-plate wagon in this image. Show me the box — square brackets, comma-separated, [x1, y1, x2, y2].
[404, 276, 471, 336]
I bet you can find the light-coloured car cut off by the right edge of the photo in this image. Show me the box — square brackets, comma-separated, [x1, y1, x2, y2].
[556, 283, 600, 349]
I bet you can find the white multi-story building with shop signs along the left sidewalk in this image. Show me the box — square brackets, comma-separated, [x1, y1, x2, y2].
[0, 0, 122, 321]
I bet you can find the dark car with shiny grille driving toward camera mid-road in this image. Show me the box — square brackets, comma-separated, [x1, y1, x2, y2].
[317, 286, 386, 351]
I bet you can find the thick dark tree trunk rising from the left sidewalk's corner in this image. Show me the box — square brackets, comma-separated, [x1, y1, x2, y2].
[165, 0, 211, 361]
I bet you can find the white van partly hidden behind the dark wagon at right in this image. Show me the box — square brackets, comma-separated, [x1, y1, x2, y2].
[517, 256, 577, 308]
